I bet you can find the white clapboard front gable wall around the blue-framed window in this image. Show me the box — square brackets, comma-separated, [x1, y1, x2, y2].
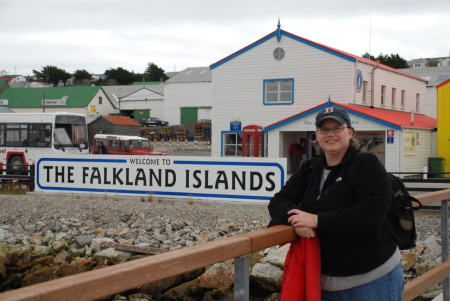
[212, 36, 354, 156]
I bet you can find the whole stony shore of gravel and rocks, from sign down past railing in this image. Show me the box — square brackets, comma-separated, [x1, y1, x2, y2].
[0, 193, 441, 301]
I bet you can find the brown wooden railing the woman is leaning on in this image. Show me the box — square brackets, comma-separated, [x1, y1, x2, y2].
[0, 189, 450, 301]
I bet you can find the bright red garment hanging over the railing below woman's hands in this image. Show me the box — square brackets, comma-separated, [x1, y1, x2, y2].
[281, 231, 321, 301]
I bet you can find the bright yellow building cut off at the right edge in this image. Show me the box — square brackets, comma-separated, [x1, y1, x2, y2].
[436, 79, 450, 176]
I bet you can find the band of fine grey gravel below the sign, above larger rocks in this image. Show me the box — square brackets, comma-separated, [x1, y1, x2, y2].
[0, 193, 441, 247]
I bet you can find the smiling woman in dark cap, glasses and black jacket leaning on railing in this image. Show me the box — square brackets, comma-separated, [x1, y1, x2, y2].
[269, 107, 404, 301]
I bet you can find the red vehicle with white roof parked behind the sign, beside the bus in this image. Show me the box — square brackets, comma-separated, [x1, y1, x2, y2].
[92, 134, 167, 156]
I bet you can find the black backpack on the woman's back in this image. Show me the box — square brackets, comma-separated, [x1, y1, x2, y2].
[386, 173, 422, 250]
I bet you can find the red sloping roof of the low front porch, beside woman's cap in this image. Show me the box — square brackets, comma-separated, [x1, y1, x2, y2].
[335, 104, 437, 129]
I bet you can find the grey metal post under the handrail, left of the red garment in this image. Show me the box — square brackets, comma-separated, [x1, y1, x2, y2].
[234, 255, 250, 301]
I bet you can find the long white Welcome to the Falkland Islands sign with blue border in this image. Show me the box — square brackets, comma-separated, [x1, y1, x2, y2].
[36, 155, 286, 200]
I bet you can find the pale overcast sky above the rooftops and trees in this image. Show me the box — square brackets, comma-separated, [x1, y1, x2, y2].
[0, 0, 450, 75]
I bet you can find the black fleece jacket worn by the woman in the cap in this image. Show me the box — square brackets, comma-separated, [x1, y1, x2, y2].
[269, 148, 397, 276]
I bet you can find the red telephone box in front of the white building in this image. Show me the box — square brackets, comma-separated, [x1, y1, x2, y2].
[242, 125, 264, 157]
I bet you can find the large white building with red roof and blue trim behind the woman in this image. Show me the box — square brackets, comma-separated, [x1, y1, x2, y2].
[210, 23, 437, 172]
